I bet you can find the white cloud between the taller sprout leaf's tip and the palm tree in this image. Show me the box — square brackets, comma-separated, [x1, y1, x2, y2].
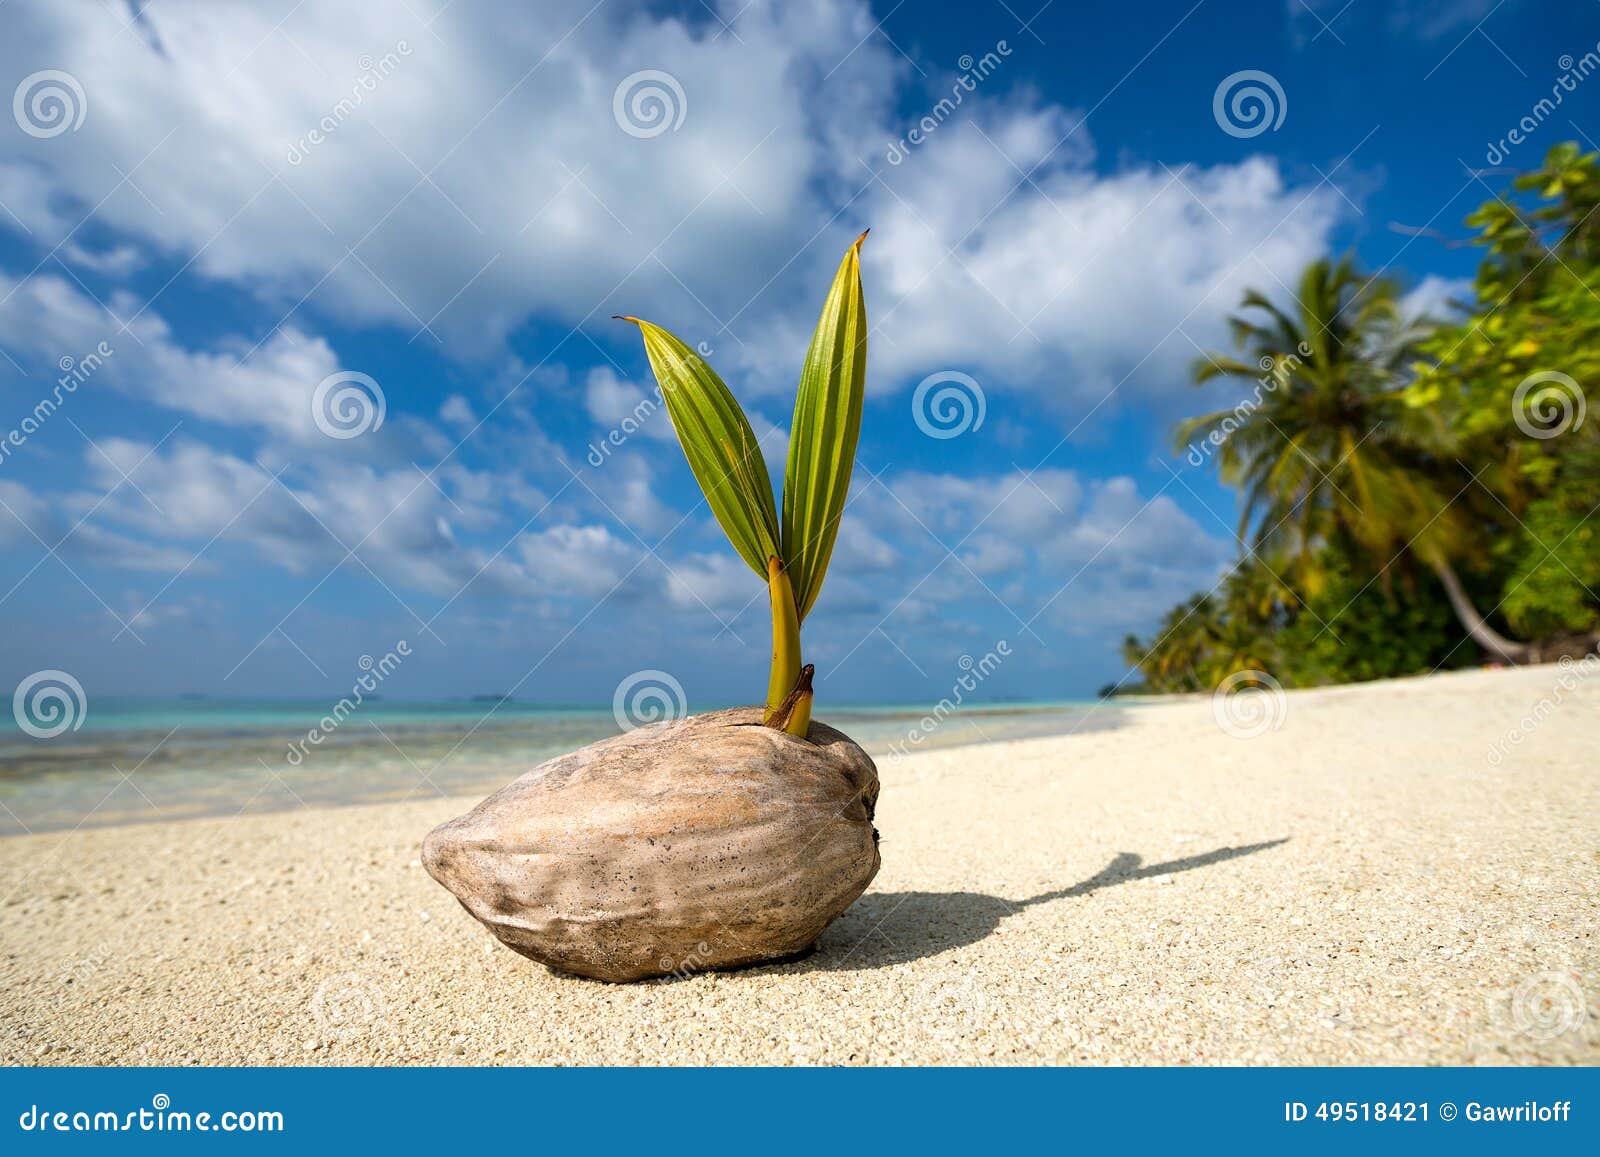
[866, 136, 1338, 416]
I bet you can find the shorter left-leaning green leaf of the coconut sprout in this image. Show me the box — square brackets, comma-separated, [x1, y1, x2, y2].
[621, 317, 780, 581]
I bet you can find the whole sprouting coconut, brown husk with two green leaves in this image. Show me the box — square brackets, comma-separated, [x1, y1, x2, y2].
[422, 234, 878, 981]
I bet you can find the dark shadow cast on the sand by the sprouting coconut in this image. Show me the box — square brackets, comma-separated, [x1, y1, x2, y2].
[789, 837, 1288, 971]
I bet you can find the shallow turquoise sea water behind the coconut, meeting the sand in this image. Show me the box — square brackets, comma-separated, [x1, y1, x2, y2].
[0, 699, 1126, 835]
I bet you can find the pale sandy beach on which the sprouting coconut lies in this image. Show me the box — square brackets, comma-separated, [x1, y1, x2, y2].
[0, 666, 1600, 1064]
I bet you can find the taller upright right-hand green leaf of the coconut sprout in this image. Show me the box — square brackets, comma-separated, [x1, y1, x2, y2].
[782, 234, 867, 619]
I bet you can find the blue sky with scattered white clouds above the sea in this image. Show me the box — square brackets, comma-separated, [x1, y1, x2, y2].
[0, 0, 1600, 714]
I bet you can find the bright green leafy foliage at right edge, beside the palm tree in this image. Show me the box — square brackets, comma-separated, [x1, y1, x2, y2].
[1406, 142, 1600, 639]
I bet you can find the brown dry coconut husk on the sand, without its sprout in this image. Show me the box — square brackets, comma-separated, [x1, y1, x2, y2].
[422, 707, 878, 981]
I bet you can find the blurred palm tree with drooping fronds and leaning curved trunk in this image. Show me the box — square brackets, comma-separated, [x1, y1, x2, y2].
[1178, 259, 1530, 663]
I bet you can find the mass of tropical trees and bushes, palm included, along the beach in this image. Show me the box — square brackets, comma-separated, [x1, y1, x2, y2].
[1123, 142, 1600, 691]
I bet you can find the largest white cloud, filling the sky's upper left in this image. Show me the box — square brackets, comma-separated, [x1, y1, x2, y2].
[0, 0, 896, 352]
